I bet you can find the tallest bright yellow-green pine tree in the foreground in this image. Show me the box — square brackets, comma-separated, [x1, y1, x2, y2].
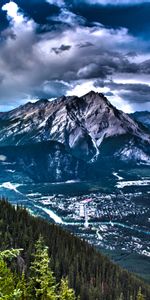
[29, 237, 57, 300]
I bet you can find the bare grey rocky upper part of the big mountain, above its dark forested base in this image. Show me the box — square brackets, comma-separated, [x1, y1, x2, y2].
[0, 91, 149, 156]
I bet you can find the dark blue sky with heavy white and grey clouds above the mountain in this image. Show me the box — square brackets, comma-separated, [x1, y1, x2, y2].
[0, 0, 150, 113]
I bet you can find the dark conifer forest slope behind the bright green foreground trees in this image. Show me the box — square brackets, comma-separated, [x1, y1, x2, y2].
[0, 200, 150, 300]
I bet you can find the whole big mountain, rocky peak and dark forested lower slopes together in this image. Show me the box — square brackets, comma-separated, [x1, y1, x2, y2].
[0, 91, 150, 182]
